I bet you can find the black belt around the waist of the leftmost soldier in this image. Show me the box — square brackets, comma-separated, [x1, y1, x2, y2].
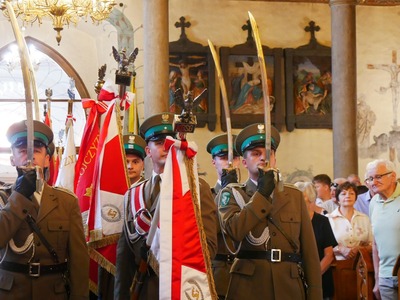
[0, 261, 67, 277]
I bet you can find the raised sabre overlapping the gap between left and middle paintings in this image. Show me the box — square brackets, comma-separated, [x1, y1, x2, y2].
[208, 40, 234, 172]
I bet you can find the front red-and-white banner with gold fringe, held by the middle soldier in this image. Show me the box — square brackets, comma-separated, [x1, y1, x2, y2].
[156, 137, 215, 299]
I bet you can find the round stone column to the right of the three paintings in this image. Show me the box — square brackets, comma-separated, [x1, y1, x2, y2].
[330, 0, 358, 178]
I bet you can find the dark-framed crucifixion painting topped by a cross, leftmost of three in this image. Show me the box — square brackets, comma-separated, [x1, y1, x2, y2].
[168, 17, 216, 131]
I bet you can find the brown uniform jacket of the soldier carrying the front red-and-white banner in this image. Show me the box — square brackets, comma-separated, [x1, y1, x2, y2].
[114, 178, 217, 300]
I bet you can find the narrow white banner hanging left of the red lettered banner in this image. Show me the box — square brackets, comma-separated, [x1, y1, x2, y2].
[55, 115, 76, 192]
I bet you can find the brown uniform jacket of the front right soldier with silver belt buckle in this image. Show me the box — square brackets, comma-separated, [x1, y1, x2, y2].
[218, 179, 322, 300]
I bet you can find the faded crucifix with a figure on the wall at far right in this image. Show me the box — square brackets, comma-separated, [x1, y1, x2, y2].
[367, 50, 400, 131]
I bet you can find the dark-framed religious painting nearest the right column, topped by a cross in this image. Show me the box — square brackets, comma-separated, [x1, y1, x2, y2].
[284, 21, 332, 131]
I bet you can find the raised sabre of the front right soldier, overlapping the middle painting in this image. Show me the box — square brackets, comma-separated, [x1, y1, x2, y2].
[248, 12, 271, 168]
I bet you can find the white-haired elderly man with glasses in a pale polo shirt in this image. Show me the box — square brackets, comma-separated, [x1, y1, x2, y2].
[365, 159, 400, 299]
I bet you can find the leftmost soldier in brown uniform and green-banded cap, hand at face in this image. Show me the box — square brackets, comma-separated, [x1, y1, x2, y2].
[0, 121, 89, 300]
